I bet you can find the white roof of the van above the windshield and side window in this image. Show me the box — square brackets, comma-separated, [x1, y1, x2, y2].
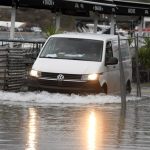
[51, 32, 123, 41]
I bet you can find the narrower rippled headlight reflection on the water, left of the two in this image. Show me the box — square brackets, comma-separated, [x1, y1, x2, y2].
[25, 108, 37, 150]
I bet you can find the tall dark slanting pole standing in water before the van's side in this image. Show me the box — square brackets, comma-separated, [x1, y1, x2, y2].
[118, 35, 126, 110]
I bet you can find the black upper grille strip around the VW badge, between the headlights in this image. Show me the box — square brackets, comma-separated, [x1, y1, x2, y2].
[41, 72, 82, 80]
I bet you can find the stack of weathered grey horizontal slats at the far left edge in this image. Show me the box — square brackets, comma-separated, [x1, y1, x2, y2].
[0, 49, 26, 91]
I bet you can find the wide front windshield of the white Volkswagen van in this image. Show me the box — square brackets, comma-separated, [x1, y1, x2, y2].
[40, 37, 103, 61]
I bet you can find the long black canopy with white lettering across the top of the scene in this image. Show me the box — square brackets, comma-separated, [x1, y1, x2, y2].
[0, 0, 150, 16]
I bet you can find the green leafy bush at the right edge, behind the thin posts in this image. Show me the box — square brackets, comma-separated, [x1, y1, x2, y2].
[139, 37, 150, 69]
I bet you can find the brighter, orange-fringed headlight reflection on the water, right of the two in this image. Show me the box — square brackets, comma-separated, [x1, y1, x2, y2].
[88, 111, 96, 150]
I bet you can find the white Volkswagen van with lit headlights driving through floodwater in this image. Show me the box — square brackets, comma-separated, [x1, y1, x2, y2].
[29, 33, 132, 93]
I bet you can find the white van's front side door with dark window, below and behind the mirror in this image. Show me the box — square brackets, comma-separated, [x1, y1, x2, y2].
[105, 41, 120, 93]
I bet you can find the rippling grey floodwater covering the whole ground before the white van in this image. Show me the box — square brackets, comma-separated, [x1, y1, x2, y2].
[0, 91, 150, 150]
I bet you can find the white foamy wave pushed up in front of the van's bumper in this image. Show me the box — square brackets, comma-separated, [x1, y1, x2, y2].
[0, 91, 144, 104]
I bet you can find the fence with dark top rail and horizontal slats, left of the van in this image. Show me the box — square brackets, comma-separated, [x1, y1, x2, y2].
[0, 40, 44, 91]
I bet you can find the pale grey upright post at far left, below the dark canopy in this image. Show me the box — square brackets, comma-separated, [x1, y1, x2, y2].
[10, 6, 16, 48]
